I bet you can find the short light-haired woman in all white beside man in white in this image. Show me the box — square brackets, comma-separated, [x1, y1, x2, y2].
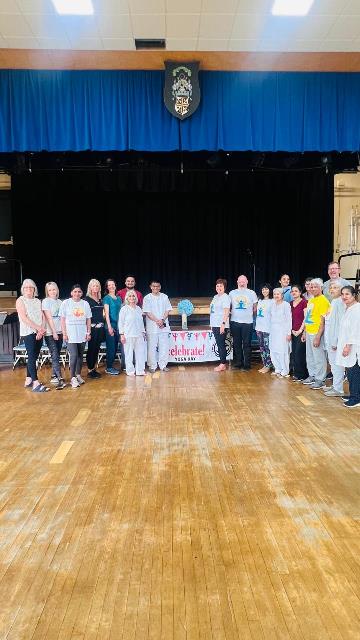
[119, 289, 145, 376]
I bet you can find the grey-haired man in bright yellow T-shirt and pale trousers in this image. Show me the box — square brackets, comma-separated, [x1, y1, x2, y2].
[301, 278, 330, 389]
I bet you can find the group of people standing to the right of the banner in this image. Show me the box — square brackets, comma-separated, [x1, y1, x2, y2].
[210, 262, 360, 408]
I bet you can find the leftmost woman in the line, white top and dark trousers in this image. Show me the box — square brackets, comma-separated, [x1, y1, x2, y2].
[16, 278, 50, 393]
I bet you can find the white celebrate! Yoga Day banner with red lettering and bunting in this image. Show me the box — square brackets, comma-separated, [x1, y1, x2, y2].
[169, 331, 232, 362]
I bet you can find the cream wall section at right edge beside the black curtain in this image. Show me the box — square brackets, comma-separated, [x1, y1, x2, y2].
[334, 173, 360, 280]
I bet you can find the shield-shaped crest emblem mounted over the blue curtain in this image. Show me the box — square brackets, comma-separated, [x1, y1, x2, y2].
[164, 60, 200, 120]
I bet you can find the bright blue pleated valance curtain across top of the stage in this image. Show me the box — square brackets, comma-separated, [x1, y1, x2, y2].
[0, 70, 360, 152]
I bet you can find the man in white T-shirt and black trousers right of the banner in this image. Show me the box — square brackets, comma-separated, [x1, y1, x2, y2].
[229, 275, 257, 371]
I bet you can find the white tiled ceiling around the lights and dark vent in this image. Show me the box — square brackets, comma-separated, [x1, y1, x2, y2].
[0, 0, 360, 51]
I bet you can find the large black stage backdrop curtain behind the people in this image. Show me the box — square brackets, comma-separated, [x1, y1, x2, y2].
[12, 170, 334, 296]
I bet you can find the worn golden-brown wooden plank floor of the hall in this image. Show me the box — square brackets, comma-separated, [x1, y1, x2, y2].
[0, 365, 360, 640]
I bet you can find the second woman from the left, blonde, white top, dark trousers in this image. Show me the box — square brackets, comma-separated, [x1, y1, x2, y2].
[41, 282, 66, 390]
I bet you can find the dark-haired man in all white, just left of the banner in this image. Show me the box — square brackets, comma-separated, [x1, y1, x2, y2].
[143, 280, 172, 373]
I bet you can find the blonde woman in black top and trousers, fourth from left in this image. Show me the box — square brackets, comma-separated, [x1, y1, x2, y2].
[84, 278, 105, 380]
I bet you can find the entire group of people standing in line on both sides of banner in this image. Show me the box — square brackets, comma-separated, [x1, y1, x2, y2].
[16, 262, 360, 407]
